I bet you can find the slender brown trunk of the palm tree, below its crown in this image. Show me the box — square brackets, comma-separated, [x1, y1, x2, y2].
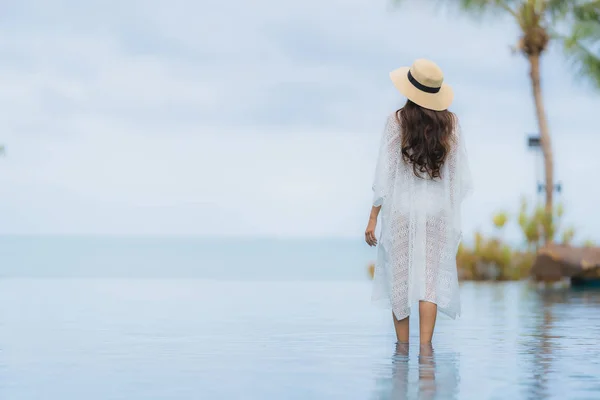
[528, 54, 554, 238]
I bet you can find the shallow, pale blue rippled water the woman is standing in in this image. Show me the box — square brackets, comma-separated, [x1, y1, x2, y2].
[0, 279, 600, 400]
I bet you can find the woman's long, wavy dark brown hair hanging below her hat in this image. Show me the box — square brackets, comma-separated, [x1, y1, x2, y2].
[396, 100, 458, 179]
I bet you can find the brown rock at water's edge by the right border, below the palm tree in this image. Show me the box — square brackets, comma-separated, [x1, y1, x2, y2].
[531, 244, 600, 282]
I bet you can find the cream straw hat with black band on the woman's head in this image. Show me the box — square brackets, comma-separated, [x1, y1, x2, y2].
[390, 59, 454, 111]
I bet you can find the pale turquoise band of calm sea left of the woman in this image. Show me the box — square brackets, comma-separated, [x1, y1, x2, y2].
[0, 236, 376, 281]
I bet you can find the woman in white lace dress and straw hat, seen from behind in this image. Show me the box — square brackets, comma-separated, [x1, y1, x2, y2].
[365, 59, 471, 344]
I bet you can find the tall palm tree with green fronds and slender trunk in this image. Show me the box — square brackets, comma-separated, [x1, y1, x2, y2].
[396, 0, 600, 217]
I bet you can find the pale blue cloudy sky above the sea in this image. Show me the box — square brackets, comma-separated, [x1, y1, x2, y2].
[0, 0, 600, 241]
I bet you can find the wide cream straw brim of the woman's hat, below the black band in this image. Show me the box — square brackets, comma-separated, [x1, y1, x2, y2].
[390, 67, 454, 111]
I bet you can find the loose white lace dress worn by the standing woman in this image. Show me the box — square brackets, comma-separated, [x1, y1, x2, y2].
[372, 113, 472, 319]
